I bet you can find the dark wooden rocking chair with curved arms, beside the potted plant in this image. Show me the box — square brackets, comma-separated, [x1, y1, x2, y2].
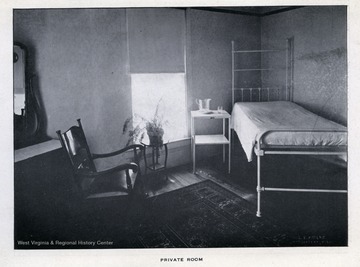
[56, 119, 144, 202]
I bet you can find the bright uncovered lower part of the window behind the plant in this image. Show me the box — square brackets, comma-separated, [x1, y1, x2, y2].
[131, 73, 188, 141]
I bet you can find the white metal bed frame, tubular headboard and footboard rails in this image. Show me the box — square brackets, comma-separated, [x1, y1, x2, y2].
[232, 39, 347, 217]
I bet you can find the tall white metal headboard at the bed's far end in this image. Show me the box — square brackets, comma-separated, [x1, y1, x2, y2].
[231, 37, 294, 106]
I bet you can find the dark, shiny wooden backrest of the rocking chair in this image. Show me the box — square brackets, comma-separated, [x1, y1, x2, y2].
[56, 119, 96, 174]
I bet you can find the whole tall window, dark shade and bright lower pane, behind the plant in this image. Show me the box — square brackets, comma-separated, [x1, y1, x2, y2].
[126, 8, 188, 141]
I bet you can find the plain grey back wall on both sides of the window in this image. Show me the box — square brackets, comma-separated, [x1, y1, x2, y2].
[14, 9, 260, 168]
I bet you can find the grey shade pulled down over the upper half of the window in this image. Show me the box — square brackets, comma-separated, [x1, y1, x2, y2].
[127, 8, 185, 73]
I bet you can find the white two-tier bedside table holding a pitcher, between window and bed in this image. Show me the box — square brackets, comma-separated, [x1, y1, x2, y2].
[191, 110, 231, 173]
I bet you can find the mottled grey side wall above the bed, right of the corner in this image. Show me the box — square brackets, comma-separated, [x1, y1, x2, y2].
[261, 6, 347, 125]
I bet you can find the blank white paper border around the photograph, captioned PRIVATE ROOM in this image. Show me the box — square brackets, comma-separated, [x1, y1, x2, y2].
[0, 0, 360, 267]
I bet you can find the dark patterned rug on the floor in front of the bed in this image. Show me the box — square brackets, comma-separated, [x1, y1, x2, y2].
[123, 180, 336, 248]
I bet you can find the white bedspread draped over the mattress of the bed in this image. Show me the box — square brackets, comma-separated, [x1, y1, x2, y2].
[231, 101, 347, 162]
